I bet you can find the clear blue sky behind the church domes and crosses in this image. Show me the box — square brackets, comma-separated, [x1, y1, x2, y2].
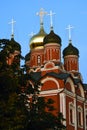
[0, 0, 87, 82]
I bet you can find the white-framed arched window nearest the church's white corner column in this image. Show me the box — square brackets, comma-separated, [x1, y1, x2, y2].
[69, 102, 75, 125]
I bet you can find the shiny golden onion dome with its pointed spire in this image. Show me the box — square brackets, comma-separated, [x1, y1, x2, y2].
[30, 24, 47, 49]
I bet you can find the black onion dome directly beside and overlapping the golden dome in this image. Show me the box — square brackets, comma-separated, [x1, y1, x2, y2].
[43, 30, 61, 45]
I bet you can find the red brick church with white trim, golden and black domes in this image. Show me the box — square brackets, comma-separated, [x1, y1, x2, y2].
[25, 9, 87, 130]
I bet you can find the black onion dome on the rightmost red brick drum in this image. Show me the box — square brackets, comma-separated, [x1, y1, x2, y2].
[63, 40, 79, 57]
